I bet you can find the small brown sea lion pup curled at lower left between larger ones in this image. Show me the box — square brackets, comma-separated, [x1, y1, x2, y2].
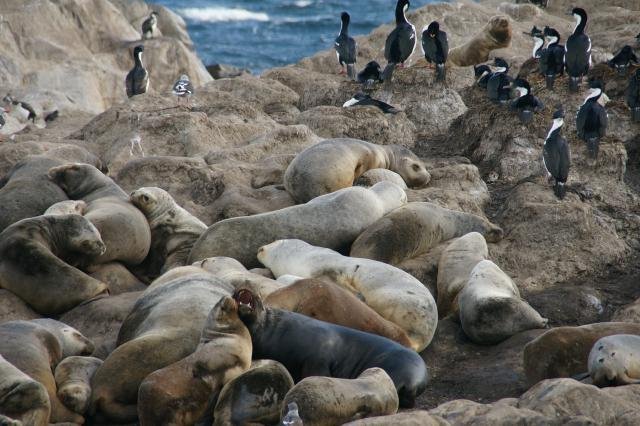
[54, 356, 102, 414]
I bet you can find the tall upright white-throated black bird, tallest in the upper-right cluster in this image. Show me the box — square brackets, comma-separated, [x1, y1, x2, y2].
[564, 7, 591, 92]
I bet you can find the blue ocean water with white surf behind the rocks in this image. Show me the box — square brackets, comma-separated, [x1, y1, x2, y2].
[154, 0, 433, 74]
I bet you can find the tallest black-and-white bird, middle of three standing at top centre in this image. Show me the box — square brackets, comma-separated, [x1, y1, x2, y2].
[382, 0, 416, 81]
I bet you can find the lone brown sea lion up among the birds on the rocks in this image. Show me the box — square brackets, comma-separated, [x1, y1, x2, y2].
[448, 15, 511, 67]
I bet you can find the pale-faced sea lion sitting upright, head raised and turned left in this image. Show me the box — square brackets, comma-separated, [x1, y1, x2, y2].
[129, 187, 207, 278]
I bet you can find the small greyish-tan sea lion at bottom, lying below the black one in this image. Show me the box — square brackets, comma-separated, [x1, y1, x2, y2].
[282, 368, 398, 426]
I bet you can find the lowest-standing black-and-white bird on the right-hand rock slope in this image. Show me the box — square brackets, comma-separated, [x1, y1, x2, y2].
[542, 107, 571, 199]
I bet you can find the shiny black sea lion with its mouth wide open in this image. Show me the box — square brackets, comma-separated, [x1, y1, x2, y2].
[233, 290, 427, 408]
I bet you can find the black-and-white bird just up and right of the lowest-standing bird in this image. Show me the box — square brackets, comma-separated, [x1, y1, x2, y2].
[576, 80, 609, 160]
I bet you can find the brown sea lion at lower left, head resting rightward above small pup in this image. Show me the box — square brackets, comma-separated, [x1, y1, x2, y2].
[0, 319, 93, 424]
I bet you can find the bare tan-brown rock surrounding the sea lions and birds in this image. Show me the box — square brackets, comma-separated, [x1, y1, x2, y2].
[0, 0, 640, 425]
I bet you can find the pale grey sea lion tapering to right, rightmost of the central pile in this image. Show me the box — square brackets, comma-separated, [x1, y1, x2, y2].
[458, 260, 548, 345]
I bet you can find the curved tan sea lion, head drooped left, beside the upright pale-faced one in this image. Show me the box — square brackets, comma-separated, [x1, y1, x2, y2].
[49, 163, 151, 265]
